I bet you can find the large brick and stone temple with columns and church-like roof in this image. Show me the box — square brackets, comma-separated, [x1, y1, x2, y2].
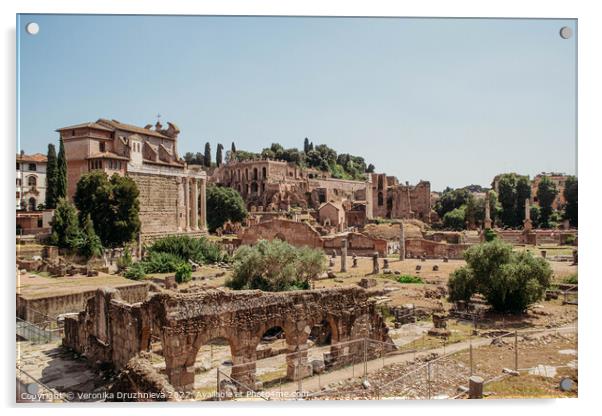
[57, 118, 207, 240]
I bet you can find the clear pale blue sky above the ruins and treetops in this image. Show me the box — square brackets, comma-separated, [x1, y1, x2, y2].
[17, 15, 577, 191]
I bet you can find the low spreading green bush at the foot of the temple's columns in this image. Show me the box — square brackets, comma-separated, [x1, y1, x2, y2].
[148, 235, 226, 263]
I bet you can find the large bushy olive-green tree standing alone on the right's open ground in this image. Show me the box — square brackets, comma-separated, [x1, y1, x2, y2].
[448, 239, 552, 312]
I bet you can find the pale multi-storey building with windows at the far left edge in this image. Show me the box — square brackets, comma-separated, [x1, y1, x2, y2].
[16, 152, 48, 211]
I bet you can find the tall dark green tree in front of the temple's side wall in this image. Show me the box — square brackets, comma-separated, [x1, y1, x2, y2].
[73, 171, 140, 247]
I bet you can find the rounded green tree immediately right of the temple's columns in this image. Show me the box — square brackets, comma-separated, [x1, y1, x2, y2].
[206, 186, 247, 232]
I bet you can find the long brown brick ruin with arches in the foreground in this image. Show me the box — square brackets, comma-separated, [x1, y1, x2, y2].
[63, 287, 390, 391]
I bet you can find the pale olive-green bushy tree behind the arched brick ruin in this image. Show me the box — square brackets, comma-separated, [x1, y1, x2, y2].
[226, 239, 326, 292]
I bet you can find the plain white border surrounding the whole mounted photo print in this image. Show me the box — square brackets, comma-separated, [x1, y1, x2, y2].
[0, 0, 602, 416]
